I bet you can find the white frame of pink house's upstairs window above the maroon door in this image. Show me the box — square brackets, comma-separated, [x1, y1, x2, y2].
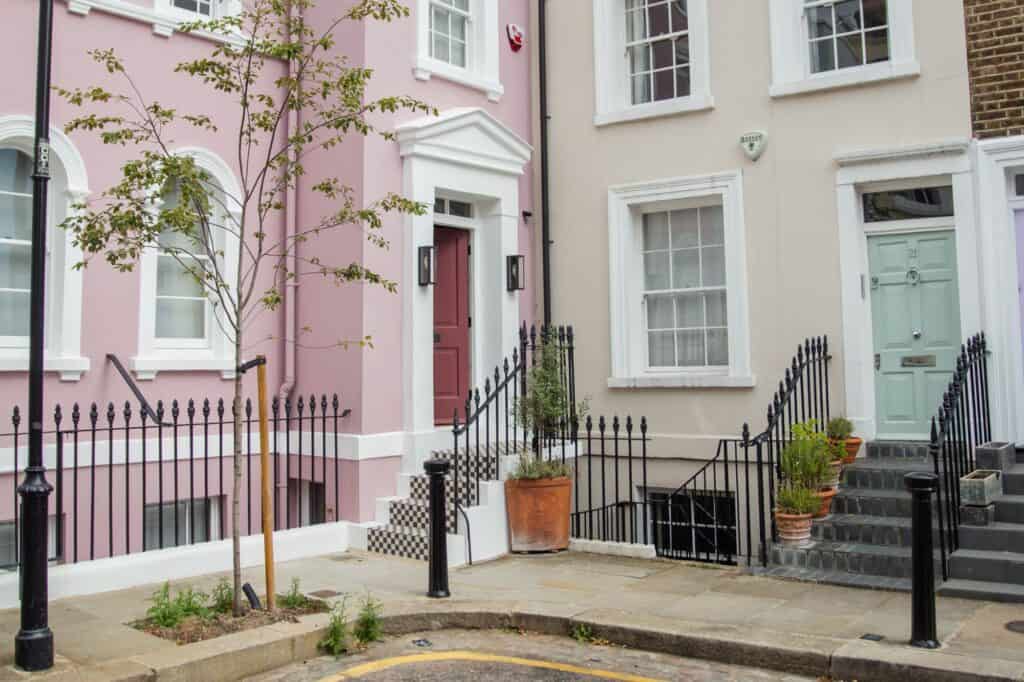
[413, 0, 505, 101]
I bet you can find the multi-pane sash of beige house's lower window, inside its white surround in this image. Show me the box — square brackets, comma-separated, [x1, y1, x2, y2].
[642, 206, 729, 369]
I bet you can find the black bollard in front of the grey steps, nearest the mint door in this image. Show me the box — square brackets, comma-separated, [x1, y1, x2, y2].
[903, 471, 939, 649]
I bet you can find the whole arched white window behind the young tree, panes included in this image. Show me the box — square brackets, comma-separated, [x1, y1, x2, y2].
[132, 148, 241, 379]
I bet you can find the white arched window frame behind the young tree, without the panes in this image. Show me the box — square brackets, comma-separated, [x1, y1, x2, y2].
[131, 147, 242, 381]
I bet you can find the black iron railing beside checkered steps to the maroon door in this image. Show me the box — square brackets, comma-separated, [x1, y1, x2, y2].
[452, 324, 575, 507]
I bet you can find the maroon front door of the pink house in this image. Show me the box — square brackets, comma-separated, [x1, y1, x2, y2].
[434, 227, 469, 424]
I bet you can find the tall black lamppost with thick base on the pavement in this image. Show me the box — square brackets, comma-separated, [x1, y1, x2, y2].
[14, 0, 53, 671]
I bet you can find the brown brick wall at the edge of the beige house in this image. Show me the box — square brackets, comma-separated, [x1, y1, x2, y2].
[966, 0, 1024, 137]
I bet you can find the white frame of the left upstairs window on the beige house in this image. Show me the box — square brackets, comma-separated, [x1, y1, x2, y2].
[593, 0, 715, 126]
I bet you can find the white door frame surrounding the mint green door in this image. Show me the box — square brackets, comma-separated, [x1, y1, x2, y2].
[835, 139, 982, 440]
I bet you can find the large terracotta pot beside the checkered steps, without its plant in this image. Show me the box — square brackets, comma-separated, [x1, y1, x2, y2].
[505, 477, 572, 552]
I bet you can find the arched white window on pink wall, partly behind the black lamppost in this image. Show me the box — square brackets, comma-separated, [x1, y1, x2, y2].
[0, 116, 89, 381]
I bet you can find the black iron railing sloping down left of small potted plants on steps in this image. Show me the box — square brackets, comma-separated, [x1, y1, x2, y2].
[649, 336, 831, 565]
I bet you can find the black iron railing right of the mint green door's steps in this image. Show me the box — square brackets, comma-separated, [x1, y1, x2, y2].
[929, 334, 992, 581]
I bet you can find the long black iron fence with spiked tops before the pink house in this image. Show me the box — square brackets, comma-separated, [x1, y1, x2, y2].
[0, 394, 346, 567]
